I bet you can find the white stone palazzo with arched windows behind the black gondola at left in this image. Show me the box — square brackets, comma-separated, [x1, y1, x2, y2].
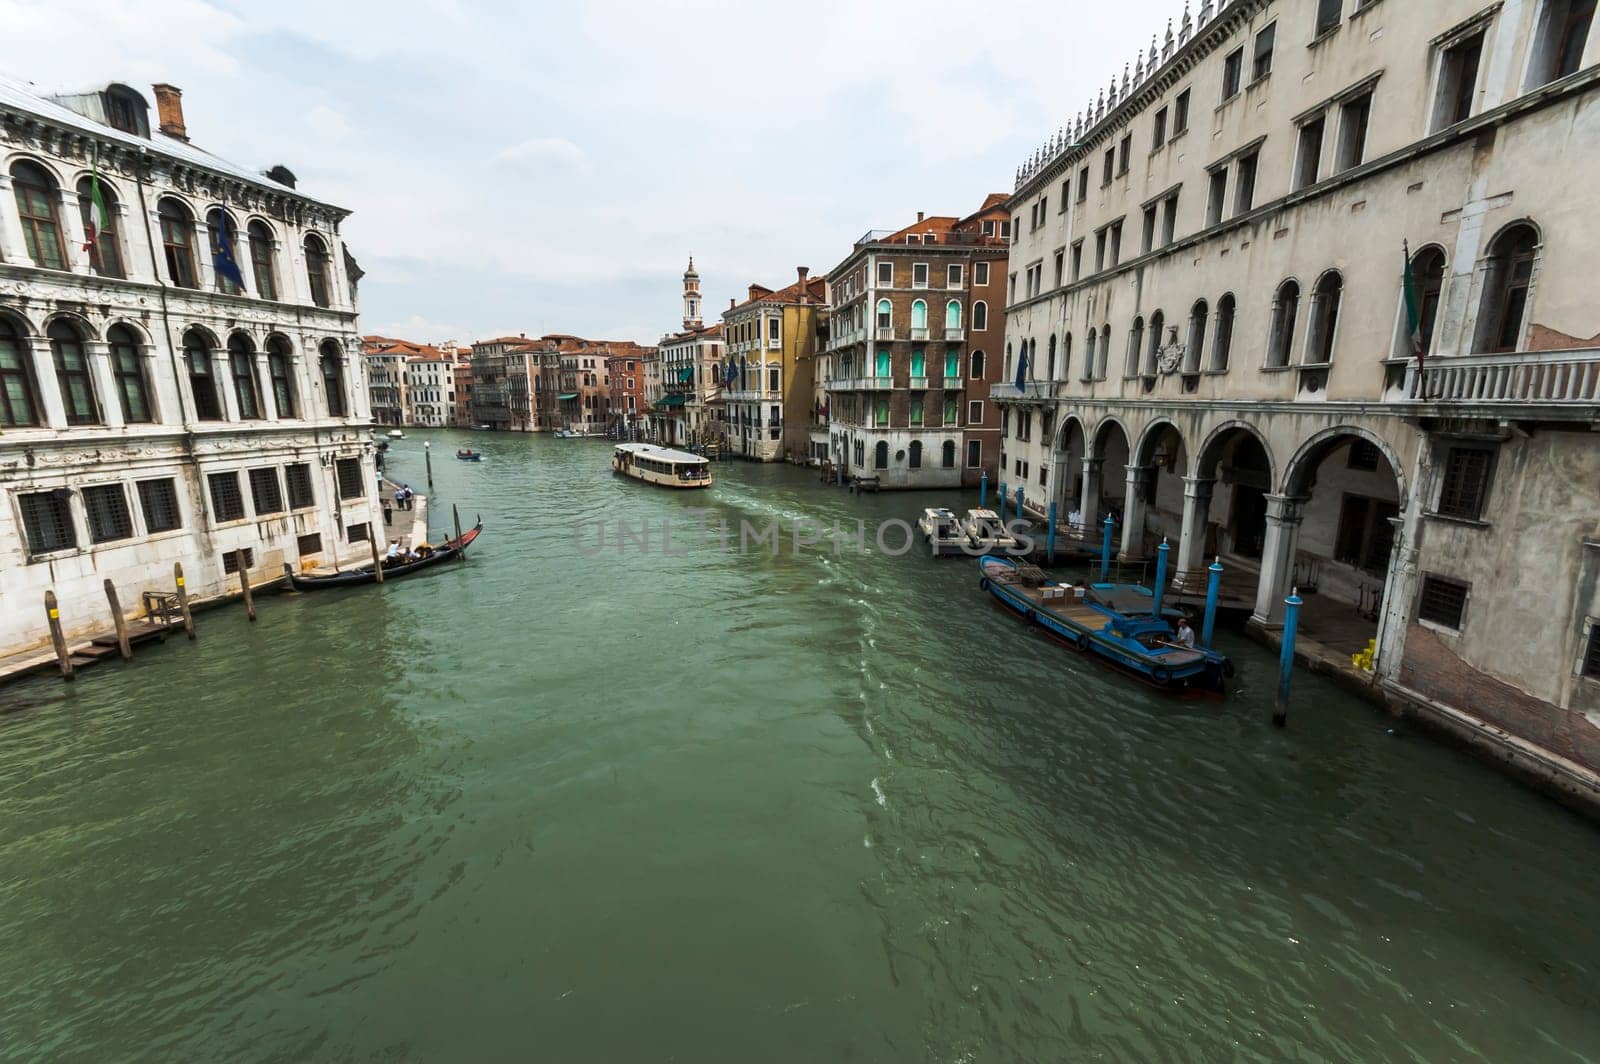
[0, 78, 378, 653]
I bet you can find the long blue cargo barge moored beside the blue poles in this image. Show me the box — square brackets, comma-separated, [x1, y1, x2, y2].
[979, 555, 1234, 694]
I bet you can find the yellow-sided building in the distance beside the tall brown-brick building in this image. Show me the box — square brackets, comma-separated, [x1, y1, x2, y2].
[720, 266, 827, 462]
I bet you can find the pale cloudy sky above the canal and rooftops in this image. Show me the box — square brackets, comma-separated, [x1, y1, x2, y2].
[9, 0, 1198, 342]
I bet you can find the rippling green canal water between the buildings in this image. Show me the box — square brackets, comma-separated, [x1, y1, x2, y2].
[0, 432, 1600, 1062]
